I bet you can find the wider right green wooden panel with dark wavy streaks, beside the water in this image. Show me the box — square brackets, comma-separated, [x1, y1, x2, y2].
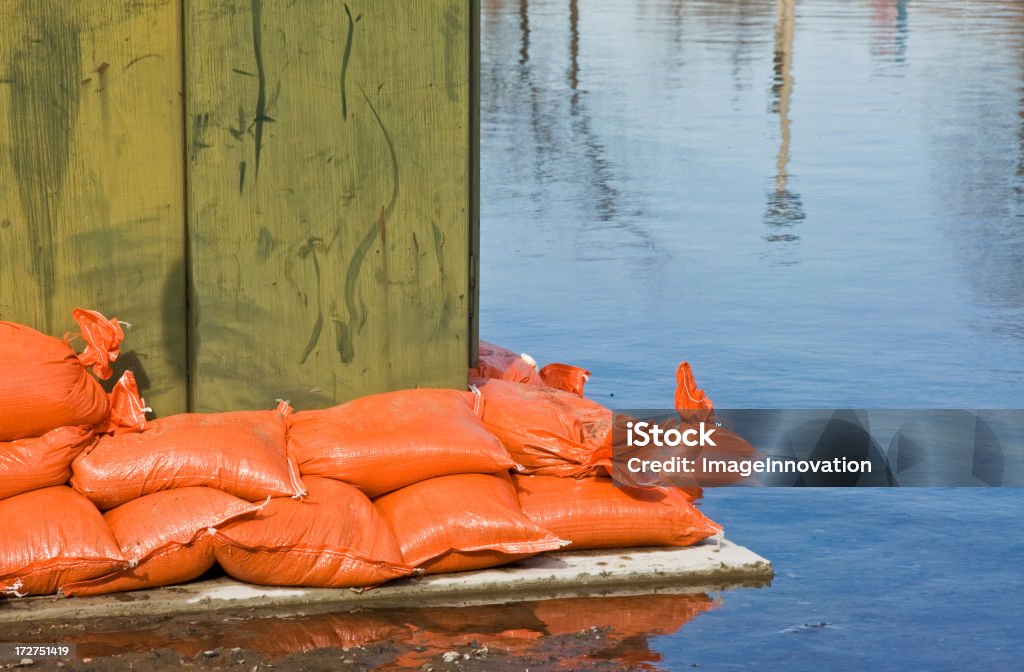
[185, 0, 475, 411]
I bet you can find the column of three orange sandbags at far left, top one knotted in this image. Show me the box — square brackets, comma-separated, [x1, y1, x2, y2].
[0, 309, 128, 595]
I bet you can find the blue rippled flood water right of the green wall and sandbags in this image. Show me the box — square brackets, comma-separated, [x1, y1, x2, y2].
[480, 0, 1024, 670]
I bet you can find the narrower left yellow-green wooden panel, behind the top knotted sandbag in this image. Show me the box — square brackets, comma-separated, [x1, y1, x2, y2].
[0, 0, 186, 415]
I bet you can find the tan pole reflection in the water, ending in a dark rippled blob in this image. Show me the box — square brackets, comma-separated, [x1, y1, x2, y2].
[764, 0, 805, 258]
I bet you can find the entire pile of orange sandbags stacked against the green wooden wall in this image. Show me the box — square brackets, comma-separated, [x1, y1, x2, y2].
[0, 309, 737, 595]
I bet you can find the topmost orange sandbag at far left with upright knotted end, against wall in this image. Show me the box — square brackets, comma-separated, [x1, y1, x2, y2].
[0, 308, 124, 442]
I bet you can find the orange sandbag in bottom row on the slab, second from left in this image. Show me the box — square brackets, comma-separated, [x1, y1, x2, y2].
[63, 488, 259, 595]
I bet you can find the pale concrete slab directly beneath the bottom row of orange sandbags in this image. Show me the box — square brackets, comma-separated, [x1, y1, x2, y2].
[0, 540, 774, 624]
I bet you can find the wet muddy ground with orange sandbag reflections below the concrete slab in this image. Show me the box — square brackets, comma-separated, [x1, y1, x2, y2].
[3, 588, 733, 672]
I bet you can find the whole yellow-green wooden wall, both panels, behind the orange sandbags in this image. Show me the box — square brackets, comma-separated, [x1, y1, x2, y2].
[0, 0, 478, 415]
